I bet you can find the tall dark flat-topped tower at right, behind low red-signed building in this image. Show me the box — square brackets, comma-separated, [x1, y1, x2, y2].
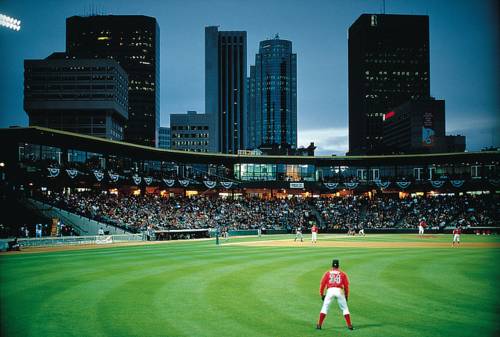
[349, 14, 430, 155]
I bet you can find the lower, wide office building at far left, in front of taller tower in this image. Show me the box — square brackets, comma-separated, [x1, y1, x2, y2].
[24, 53, 128, 140]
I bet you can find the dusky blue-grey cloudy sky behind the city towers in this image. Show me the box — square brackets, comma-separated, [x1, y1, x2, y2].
[0, 0, 500, 154]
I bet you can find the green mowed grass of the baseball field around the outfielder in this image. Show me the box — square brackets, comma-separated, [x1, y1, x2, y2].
[0, 235, 500, 337]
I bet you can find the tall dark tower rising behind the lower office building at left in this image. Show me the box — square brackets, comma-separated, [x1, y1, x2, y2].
[66, 15, 160, 146]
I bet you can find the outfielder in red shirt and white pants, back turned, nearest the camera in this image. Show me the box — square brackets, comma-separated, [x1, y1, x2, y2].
[316, 260, 354, 330]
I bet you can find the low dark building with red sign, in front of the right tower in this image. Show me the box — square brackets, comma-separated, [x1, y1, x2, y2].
[383, 99, 465, 154]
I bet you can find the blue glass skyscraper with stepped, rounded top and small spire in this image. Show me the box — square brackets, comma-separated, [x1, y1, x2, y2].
[248, 35, 297, 149]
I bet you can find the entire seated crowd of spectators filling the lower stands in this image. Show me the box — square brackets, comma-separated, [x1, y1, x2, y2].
[36, 192, 499, 232]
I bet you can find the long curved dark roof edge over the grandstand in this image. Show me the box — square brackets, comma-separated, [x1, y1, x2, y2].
[0, 126, 500, 166]
